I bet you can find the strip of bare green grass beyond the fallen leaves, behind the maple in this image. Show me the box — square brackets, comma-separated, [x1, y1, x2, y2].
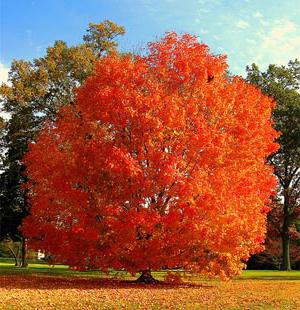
[0, 258, 300, 281]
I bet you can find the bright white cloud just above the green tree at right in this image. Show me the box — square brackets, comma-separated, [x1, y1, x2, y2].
[226, 15, 300, 75]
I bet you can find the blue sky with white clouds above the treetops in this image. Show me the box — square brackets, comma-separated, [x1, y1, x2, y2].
[0, 0, 300, 80]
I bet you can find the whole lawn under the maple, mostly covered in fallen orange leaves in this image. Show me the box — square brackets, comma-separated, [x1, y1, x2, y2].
[0, 260, 300, 309]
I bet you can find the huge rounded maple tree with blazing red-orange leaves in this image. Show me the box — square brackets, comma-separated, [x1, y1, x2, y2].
[23, 33, 277, 280]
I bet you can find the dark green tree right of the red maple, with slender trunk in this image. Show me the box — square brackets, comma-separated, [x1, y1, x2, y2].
[247, 59, 300, 270]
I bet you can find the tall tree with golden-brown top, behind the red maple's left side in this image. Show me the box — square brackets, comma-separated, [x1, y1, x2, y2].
[0, 21, 125, 266]
